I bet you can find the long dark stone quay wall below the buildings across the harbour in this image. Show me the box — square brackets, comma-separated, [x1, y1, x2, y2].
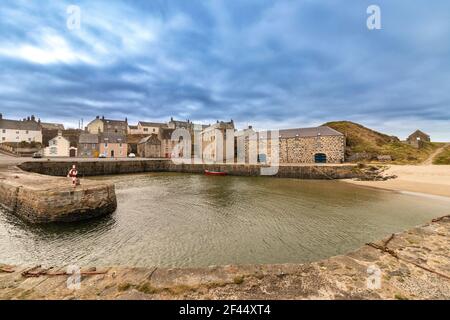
[19, 160, 359, 179]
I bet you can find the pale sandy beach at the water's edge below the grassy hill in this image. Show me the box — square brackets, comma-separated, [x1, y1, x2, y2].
[345, 165, 450, 197]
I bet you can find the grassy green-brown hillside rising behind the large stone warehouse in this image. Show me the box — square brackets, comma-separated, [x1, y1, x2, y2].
[324, 121, 439, 164]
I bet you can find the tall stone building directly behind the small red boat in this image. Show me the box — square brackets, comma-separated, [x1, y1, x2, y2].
[201, 120, 236, 163]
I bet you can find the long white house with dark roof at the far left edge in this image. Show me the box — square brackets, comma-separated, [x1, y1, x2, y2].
[0, 113, 42, 143]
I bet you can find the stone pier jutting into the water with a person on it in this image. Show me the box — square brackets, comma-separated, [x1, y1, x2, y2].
[0, 172, 117, 223]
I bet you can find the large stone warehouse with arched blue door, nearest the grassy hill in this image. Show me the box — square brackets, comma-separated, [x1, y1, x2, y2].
[279, 126, 345, 163]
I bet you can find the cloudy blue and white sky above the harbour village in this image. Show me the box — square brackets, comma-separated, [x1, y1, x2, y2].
[0, 0, 450, 141]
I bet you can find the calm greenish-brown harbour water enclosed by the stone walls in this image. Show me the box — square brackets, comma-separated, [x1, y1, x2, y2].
[0, 173, 450, 267]
